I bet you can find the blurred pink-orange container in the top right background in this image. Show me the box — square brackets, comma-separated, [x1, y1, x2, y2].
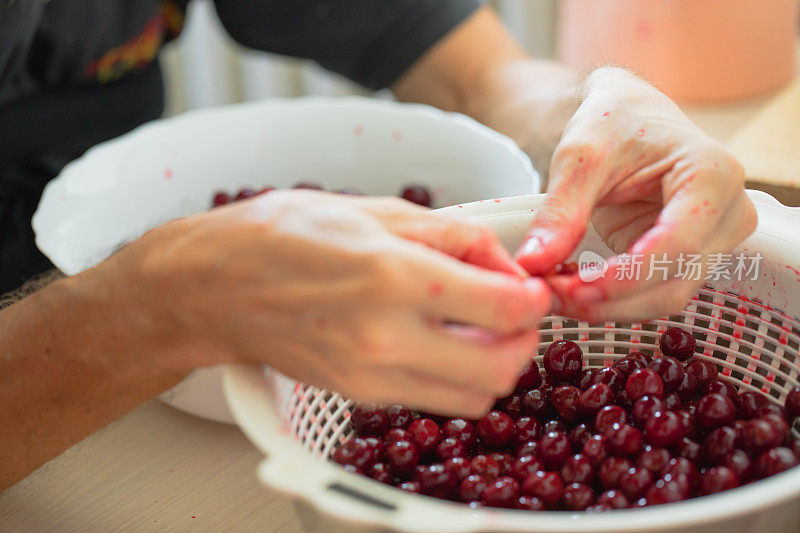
[558, 0, 798, 102]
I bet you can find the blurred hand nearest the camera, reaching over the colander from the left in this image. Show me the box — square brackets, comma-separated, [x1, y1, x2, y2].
[100, 191, 550, 416]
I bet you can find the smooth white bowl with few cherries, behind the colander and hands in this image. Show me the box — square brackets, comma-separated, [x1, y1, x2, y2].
[33, 94, 539, 422]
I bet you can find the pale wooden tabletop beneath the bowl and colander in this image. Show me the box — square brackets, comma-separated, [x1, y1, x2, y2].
[0, 79, 796, 533]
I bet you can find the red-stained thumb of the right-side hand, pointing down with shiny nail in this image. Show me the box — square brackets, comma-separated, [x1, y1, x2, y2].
[516, 158, 602, 276]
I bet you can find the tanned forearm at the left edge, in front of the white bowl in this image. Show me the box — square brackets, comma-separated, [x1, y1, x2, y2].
[0, 271, 187, 490]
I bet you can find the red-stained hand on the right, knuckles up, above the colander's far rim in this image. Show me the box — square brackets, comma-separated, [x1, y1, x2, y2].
[517, 68, 756, 322]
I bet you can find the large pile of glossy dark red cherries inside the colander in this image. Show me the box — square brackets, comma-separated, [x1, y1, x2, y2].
[332, 328, 800, 512]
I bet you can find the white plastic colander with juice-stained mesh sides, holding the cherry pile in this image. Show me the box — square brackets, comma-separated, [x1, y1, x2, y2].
[225, 191, 800, 533]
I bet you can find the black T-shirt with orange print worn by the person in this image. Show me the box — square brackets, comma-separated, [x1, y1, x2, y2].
[0, 0, 480, 292]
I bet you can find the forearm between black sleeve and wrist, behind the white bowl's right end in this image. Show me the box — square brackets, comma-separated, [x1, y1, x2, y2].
[393, 8, 580, 179]
